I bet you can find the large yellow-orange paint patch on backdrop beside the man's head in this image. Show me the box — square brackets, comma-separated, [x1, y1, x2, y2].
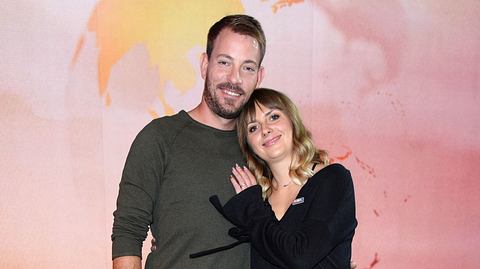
[83, 0, 244, 117]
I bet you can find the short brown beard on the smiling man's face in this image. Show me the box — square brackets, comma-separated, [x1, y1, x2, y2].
[203, 77, 245, 119]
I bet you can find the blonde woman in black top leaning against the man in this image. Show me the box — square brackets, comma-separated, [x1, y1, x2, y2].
[218, 88, 357, 269]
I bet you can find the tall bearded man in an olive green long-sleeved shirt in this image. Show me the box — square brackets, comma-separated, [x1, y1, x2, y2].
[112, 15, 266, 269]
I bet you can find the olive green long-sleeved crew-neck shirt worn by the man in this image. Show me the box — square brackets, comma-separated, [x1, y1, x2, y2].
[112, 111, 250, 269]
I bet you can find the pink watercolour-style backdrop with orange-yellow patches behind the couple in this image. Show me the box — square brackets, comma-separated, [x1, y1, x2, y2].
[0, 0, 480, 269]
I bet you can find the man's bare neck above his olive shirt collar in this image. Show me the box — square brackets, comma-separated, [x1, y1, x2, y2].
[188, 102, 236, 131]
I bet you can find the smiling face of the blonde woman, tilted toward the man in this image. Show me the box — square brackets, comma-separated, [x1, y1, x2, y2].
[247, 104, 293, 164]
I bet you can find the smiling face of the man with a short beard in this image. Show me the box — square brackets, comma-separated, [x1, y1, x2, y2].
[201, 28, 263, 119]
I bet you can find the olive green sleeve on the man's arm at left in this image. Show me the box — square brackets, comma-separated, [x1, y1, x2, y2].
[112, 125, 164, 259]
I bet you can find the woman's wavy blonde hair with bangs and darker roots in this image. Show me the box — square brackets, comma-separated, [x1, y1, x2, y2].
[237, 88, 329, 199]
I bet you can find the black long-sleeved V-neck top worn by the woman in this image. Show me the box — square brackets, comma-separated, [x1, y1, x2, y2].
[218, 164, 357, 269]
